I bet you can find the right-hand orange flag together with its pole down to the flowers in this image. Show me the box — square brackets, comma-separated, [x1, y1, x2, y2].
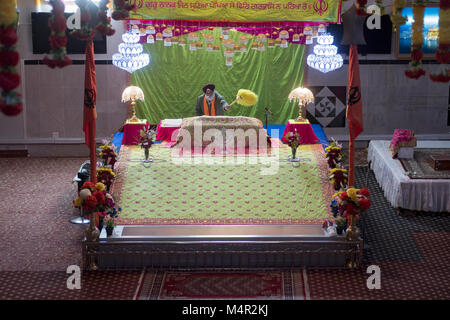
[346, 45, 363, 186]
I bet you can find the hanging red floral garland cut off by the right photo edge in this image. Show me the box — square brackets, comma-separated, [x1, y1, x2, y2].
[430, 0, 450, 82]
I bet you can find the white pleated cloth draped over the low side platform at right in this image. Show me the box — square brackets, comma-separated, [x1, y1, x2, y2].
[367, 140, 450, 212]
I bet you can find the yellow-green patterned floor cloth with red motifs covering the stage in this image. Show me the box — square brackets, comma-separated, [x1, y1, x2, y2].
[112, 145, 333, 224]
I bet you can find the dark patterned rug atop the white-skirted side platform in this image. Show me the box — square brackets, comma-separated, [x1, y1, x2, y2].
[400, 149, 450, 179]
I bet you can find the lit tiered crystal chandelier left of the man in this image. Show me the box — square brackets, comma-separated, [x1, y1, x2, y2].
[112, 33, 150, 73]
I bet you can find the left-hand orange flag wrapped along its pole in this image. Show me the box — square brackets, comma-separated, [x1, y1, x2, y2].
[83, 40, 97, 183]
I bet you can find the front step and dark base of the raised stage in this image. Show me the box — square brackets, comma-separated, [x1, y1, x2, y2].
[83, 225, 363, 269]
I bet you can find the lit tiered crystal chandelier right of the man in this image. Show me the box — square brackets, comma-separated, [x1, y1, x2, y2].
[306, 34, 344, 73]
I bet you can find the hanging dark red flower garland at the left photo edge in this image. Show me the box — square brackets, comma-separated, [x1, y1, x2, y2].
[0, 0, 23, 116]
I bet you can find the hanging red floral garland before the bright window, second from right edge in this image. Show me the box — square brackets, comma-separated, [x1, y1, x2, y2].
[405, 0, 425, 79]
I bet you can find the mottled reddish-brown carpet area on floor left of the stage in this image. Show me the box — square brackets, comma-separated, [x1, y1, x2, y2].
[0, 158, 85, 271]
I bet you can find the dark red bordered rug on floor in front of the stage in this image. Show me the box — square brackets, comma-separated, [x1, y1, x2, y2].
[137, 270, 306, 300]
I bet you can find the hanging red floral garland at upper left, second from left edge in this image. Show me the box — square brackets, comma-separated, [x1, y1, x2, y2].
[42, 0, 72, 69]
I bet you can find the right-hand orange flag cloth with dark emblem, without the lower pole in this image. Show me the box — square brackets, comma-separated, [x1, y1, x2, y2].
[346, 45, 363, 138]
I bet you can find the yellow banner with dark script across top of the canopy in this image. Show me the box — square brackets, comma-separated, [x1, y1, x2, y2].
[131, 0, 341, 22]
